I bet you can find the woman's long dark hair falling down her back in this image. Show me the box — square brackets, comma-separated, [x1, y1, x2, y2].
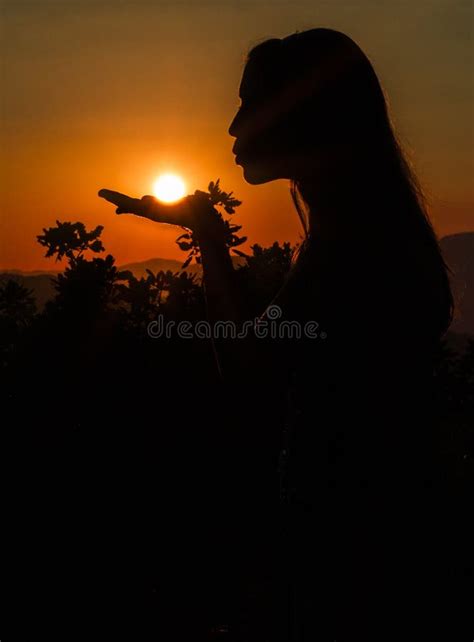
[247, 28, 453, 335]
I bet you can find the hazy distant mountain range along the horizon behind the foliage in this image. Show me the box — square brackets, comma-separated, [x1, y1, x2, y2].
[0, 232, 474, 336]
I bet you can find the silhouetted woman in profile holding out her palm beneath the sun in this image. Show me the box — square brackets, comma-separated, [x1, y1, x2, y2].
[99, 28, 452, 640]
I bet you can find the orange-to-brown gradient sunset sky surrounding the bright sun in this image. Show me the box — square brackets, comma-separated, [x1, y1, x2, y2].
[0, 0, 474, 270]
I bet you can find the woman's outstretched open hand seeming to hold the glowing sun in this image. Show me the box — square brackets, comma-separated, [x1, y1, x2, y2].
[98, 189, 223, 238]
